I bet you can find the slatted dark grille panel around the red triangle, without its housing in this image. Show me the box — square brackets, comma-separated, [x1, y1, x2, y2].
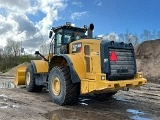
[109, 49, 135, 79]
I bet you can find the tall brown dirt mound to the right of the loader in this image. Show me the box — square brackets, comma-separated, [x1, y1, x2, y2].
[135, 39, 160, 83]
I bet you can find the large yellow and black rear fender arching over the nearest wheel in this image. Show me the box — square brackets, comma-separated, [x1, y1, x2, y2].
[50, 54, 85, 83]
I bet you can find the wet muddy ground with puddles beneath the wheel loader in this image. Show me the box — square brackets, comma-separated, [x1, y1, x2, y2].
[0, 76, 160, 120]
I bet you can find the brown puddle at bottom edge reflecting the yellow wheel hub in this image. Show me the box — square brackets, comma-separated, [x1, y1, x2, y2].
[47, 109, 106, 120]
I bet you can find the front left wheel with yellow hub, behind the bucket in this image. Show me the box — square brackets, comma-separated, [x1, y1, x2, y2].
[25, 63, 43, 92]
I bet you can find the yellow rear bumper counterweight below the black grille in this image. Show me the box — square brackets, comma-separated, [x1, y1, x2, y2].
[81, 73, 147, 94]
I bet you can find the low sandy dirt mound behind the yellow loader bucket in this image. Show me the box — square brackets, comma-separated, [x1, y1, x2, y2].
[2, 62, 28, 76]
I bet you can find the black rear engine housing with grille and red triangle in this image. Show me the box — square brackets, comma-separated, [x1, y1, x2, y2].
[101, 41, 137, 80]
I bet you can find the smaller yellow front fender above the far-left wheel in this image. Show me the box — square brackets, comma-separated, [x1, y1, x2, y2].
[31, 60, 48, 74]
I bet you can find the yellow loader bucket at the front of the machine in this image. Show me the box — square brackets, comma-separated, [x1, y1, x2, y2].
[14, 66, 27, 86]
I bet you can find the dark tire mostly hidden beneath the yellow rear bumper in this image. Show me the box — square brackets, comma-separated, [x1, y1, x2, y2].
[94, 91, 117, 101]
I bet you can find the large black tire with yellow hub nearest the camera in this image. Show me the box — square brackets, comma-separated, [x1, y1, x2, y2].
[48, 66, 80, 105]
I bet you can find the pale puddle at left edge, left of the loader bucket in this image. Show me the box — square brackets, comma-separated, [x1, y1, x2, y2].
[0, 81, 16, 89]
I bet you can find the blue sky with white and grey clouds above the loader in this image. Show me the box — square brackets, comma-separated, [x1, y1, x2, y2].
[0, 0, 160, 51]
